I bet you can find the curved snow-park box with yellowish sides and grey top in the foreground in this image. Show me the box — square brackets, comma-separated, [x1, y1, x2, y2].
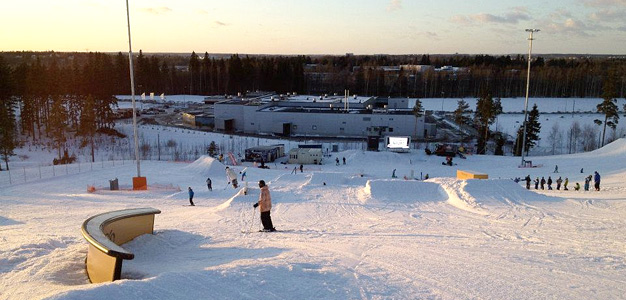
[81, 207, 161, 283]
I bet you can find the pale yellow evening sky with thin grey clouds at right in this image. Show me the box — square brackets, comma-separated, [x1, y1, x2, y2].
[0, 0, 626, 55]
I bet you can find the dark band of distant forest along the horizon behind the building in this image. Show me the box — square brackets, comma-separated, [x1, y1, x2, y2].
[0, 51, 626, 98]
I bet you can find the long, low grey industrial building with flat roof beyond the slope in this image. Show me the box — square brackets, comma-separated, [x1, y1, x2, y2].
[214, 95, 435, 138]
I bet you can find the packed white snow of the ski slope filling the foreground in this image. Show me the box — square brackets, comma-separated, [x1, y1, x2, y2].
[0, 139, 626, 300]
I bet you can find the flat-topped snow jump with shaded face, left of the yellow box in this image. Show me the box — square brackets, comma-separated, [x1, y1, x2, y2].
[363, 179, 448, 203]
